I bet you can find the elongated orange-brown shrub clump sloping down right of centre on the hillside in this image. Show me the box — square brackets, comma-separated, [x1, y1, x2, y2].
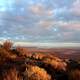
[43, 57, 67, 71]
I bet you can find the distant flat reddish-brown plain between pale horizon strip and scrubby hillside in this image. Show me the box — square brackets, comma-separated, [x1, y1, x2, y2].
[15, 47, 80, 60]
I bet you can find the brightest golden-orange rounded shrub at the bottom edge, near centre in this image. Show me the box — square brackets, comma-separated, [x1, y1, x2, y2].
[26, 66, 51, 80]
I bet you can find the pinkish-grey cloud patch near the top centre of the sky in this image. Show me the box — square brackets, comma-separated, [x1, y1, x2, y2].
[30, 4, 53, 16]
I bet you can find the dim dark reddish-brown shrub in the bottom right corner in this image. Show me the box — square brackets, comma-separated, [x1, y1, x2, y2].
[69, 69, 80, 80]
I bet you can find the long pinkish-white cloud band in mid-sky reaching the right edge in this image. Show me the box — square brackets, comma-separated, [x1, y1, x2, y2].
[36, 19, 80, 32]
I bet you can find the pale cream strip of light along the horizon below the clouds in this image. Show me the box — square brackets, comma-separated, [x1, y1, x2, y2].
[0, 41, 80, 48]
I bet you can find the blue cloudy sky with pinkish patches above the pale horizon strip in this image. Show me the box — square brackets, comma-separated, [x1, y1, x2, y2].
[0, 0, 80, 43]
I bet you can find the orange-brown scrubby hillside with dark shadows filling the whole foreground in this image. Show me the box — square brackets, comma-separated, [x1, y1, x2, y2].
[0, 41, 80, 80]
